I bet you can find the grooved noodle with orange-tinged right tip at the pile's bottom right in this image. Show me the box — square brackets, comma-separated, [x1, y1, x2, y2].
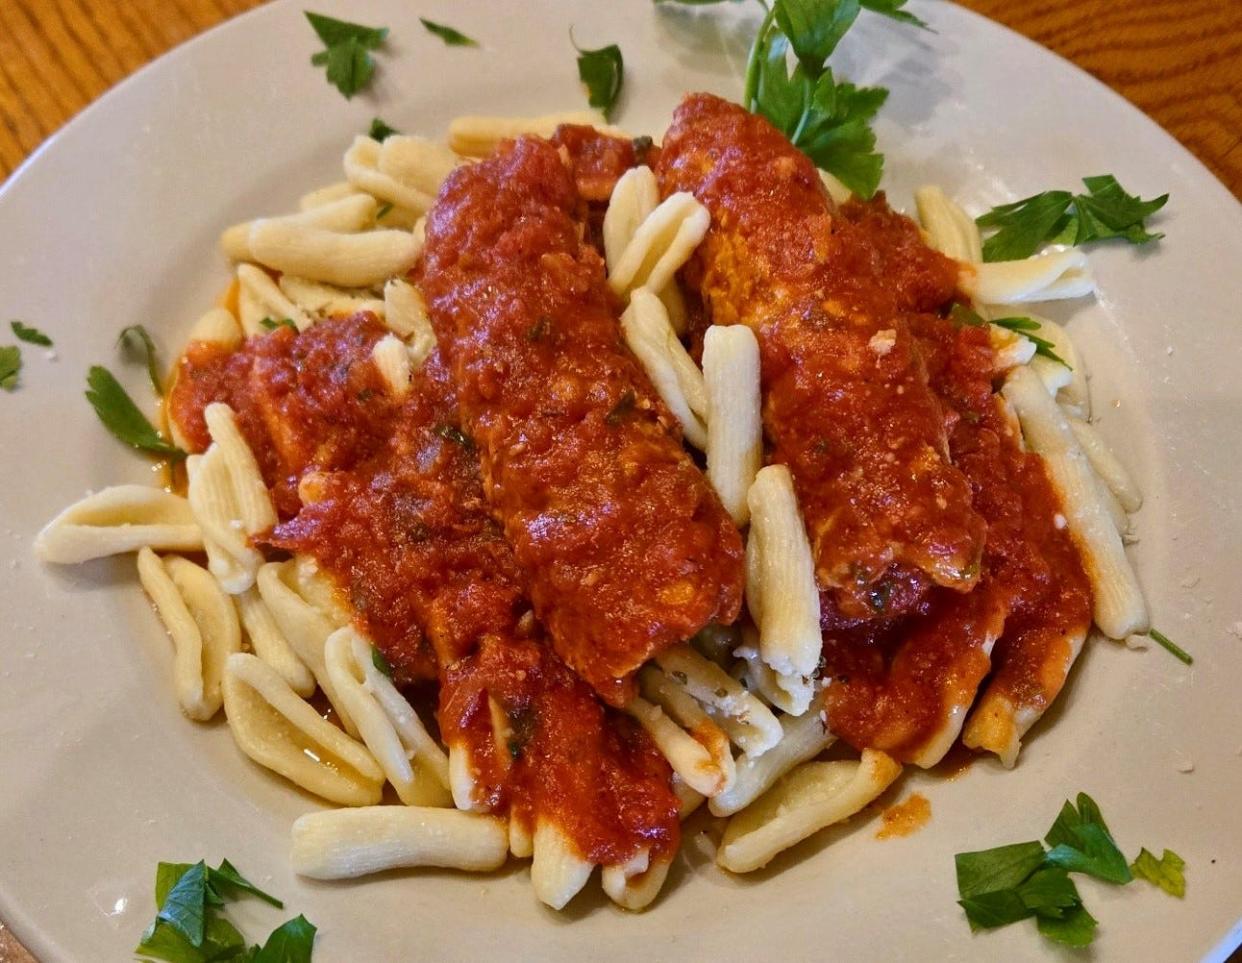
[715, 749, 902, 872]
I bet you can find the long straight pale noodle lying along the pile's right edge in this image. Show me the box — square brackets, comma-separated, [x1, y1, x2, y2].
[1001, 368, 1149, 639]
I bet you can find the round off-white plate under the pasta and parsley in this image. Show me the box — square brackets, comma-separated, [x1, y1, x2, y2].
[0, 0, 1242, 961]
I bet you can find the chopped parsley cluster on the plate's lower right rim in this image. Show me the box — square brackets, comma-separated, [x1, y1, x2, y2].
[954, 793, 1185, 947]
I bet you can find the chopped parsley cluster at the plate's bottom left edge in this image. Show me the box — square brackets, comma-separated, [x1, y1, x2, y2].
[134, 860, 315, 963]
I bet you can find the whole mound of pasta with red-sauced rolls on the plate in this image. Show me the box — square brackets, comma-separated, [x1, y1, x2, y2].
[36, 88, 1149, 910]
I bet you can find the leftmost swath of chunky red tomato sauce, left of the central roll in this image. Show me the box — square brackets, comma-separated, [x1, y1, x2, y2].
[171, 314, 679, 862]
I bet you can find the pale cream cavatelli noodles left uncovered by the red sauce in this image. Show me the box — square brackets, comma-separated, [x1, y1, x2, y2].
[36, 114, 1148, 910]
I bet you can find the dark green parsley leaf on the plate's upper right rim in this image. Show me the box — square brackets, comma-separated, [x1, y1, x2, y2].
[975, 174, 1169, 261]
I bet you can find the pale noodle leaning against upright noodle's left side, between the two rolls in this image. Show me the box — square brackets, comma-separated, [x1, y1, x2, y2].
[621, 288, 707, 449]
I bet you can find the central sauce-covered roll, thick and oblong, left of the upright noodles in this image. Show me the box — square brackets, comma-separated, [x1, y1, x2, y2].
[421, 138, 744, 706]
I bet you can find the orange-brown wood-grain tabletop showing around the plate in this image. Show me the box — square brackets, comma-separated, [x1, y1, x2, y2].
[0, 0, 1242, 963]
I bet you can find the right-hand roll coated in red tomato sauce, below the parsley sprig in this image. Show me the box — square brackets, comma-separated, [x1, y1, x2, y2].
[656, 94, 984, 619]
